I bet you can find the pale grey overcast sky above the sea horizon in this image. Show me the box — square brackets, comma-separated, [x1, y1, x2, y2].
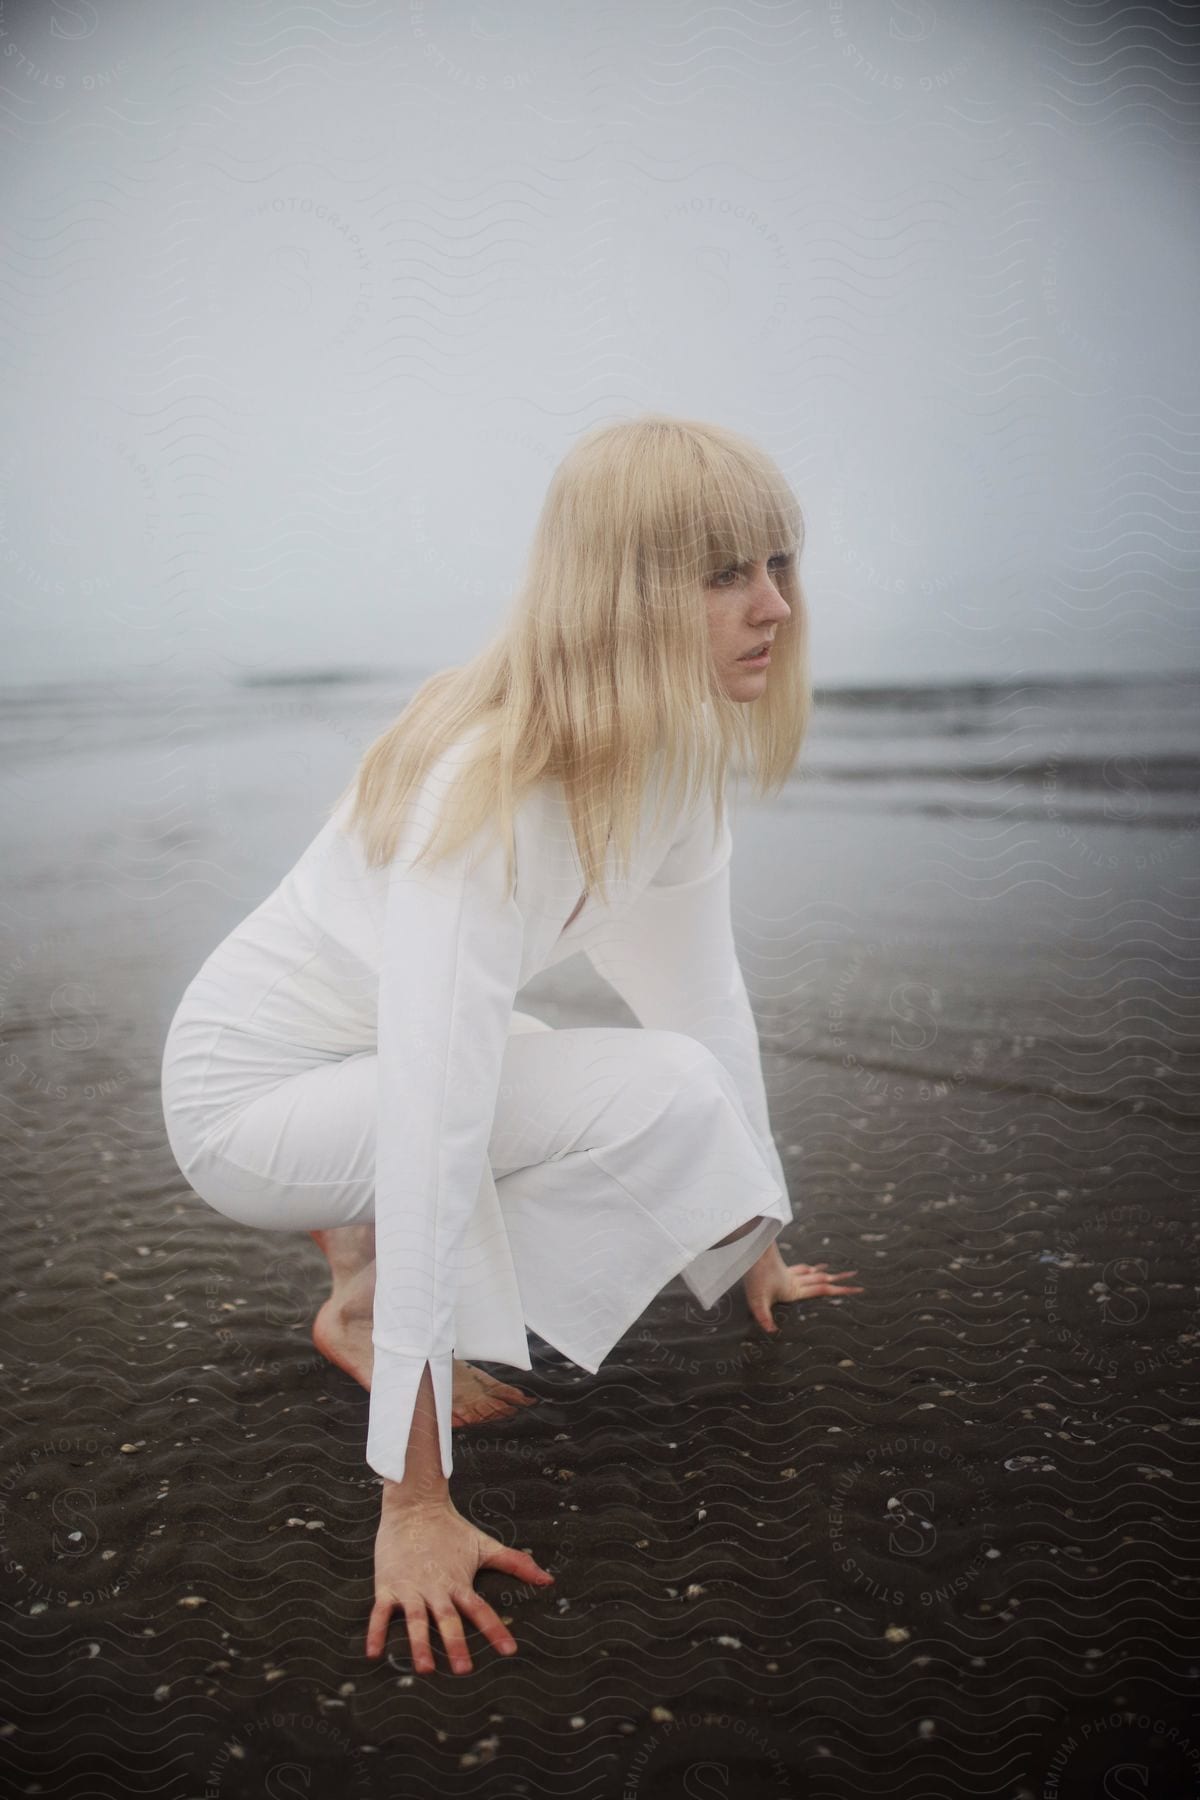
[0, 0, 1200, 682]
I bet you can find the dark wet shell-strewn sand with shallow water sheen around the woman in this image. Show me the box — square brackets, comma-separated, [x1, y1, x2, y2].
[0, 676, 1200, 1800]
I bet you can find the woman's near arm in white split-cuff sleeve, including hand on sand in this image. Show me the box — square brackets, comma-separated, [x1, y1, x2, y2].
[367, 745, 554, 1672]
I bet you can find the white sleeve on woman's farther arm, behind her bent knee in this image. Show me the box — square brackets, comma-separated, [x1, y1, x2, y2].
[587, 799, 793, 1242]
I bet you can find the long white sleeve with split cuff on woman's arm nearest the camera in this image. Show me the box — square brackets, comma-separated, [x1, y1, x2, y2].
[367, 758, 524, 1481]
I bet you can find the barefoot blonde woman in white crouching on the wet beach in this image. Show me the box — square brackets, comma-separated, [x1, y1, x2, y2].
[164, 414, 860, 1672]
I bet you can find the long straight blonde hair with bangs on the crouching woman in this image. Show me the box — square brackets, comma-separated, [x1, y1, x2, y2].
[335, 412, 811, 902]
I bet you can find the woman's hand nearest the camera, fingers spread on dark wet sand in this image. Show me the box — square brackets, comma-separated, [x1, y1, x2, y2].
[367, 1492, 554, 1674]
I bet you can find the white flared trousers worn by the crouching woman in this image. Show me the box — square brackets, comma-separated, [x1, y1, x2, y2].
[164, 1013, 792, 1368]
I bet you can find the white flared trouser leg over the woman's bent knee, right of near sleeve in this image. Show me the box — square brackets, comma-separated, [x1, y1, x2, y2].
[489, 1028, 790, 1368]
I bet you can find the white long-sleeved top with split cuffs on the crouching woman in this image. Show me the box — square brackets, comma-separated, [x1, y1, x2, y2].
[164, 733, 792, 1481]
